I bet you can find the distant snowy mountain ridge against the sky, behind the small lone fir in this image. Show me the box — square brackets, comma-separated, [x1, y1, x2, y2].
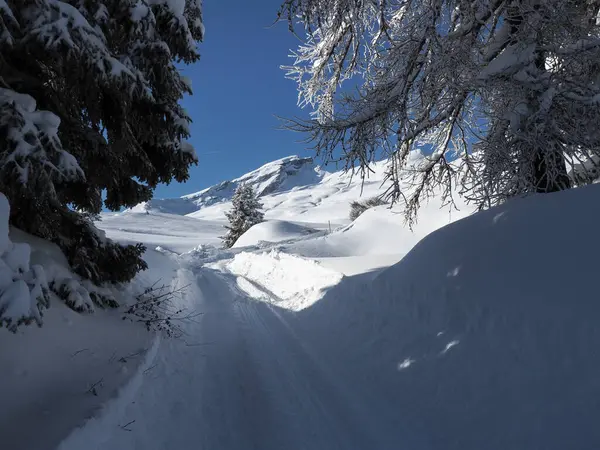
[128, 152, 473, 237]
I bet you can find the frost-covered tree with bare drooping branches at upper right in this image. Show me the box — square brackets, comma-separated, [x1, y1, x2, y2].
[279, 0, 600, 218]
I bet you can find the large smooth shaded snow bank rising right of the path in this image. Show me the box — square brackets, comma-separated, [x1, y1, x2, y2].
[296, 186, 600, 450]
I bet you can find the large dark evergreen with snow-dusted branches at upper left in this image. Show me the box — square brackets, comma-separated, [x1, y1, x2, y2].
[0, 0, 203, 283]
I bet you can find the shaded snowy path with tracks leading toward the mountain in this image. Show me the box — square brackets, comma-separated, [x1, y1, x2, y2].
[61, 269, 396, 450]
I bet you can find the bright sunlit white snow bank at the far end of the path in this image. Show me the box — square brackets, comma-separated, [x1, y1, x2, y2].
[221, 250, 343, 311]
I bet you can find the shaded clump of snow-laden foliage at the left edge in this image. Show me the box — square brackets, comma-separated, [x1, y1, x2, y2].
[0, 193, 49, 331]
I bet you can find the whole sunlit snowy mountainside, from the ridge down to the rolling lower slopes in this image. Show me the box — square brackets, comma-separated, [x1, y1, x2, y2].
[103, 152, 473, 256]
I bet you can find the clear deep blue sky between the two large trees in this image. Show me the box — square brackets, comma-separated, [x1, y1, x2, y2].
[155, 0, 312, 198]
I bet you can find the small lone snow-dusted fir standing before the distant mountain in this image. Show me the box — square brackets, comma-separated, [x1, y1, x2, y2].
[223, 183, 264, 248]
